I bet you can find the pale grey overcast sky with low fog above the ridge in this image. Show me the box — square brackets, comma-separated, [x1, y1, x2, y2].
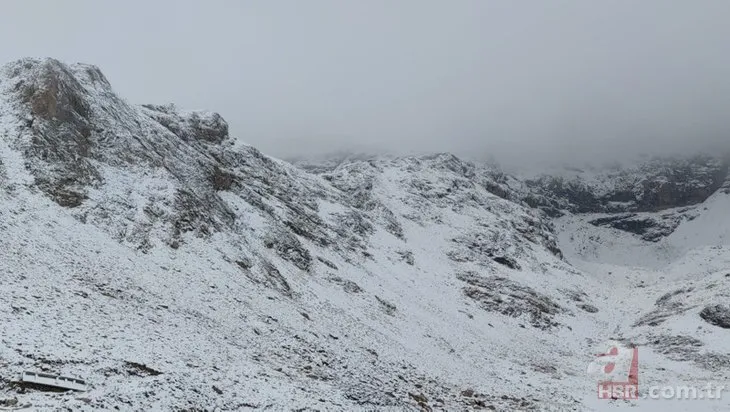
[0, 0, 730, 163]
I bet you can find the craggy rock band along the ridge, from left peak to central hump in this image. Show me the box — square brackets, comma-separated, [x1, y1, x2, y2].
[4, 59, 559, 269]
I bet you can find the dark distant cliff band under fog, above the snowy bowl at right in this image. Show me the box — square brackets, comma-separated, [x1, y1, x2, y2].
[522, 155, 730, 242]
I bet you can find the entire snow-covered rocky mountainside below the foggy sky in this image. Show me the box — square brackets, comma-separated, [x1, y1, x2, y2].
[0, 59, 730, 411]
